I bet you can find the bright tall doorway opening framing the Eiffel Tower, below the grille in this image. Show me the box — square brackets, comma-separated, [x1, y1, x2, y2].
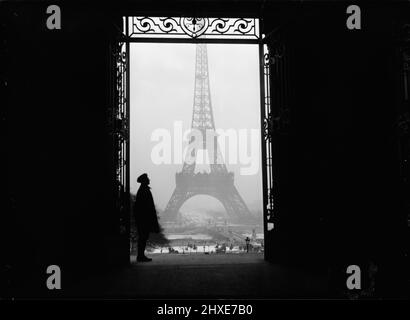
[130, 43, 264, 260]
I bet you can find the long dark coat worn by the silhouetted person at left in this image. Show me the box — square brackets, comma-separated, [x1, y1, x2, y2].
[133, 184, 159, 234]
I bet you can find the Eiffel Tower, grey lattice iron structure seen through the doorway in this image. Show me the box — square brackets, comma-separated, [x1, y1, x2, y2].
[163, 43, 251, 220]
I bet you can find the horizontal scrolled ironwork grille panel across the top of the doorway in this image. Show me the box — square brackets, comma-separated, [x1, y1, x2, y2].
[124, 17, 259, 41]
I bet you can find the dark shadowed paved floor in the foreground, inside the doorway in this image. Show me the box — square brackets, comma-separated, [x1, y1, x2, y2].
[66, 254, 328, 299]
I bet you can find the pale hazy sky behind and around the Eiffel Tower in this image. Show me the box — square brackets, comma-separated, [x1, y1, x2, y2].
[130, 43, 262, 211]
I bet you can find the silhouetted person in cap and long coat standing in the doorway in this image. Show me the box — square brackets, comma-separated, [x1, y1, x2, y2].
[134, 173, 159, 262]
